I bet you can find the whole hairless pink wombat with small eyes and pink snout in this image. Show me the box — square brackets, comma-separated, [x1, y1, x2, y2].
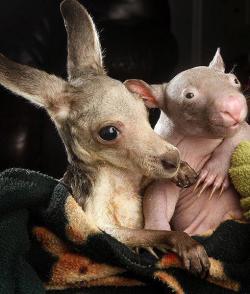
[126, 49, 250, 235]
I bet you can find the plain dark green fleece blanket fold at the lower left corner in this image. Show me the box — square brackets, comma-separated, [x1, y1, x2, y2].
[0, 169, 57, 294]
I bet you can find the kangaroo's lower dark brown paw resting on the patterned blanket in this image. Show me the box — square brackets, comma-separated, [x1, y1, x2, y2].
[168, 232, 210, 278]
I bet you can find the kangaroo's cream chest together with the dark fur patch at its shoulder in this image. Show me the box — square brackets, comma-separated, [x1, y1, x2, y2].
[64, 162, 143, 229]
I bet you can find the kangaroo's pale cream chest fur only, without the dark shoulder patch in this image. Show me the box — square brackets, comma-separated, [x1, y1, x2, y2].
[83, 164, 143, 229]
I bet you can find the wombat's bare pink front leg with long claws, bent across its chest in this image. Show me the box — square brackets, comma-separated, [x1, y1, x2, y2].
[196, 122, 250, 198]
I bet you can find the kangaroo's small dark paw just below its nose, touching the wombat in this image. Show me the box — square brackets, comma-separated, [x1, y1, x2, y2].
[172, 161, 198, 188]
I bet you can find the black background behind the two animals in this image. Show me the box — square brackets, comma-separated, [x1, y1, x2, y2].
[0, 0, 250, 177]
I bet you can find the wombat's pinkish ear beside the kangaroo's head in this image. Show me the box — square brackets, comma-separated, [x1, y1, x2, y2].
[124, 79, 164, 108]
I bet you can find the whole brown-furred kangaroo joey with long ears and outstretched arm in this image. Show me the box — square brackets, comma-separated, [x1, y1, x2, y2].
[0, 0, 209, 275]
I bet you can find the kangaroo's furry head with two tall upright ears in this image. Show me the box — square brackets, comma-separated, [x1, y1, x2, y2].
[0, 0, 179, 178]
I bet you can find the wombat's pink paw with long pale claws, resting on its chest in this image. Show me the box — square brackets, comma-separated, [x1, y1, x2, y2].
[194, 158, 229, 199]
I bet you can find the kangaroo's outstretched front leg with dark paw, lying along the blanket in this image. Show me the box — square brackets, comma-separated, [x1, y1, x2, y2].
[104, 228, 210, 277]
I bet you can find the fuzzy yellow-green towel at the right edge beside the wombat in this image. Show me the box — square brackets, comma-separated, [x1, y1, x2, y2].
[229, 141, 250, 219]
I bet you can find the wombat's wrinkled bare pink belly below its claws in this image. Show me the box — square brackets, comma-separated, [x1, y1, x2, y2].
[171, 187, 243, 235]
